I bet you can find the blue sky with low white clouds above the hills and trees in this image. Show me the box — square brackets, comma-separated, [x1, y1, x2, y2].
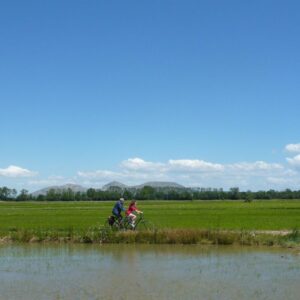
[0, 0, 300, 191]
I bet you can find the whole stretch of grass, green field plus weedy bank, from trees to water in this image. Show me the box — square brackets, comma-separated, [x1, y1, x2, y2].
[0, 200, 300, 246]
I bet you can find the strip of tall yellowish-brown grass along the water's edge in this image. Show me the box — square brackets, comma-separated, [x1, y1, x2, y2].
[1, 228, 300, 248]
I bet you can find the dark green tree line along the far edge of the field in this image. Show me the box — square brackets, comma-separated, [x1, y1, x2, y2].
[0, 186, 300, 202]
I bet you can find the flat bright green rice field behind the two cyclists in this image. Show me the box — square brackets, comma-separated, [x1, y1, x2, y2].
[0, 200, 300, 236]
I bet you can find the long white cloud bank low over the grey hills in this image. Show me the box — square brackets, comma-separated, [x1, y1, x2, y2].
[77, 158, 292, 190]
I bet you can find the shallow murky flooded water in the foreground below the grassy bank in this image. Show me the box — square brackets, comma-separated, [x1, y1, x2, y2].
[0, 245, 300, 300]
